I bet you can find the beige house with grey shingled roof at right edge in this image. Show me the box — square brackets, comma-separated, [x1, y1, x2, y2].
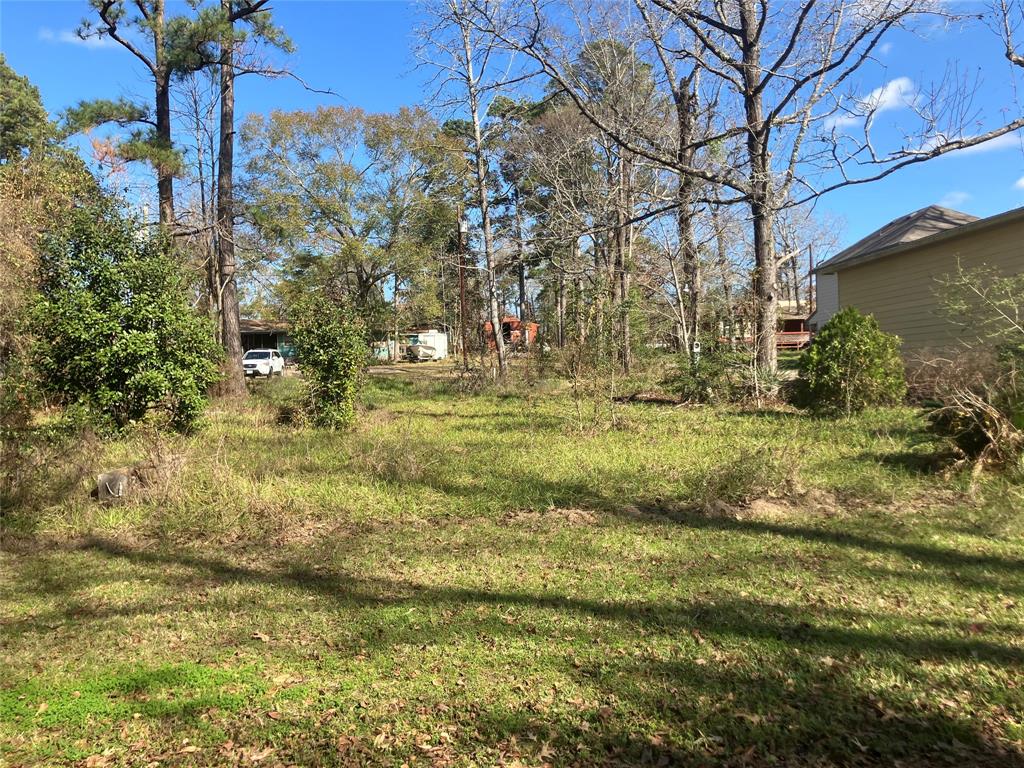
[809, 201, 1024, 354]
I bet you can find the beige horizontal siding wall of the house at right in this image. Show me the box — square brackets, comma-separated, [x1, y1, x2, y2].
[838, 220, 1024, 353]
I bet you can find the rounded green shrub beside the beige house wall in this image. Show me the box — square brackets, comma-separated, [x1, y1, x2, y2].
[798, 307, 906, 416]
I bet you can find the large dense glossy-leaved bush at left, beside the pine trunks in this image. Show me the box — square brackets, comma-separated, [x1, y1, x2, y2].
[31, 199, 217, 431]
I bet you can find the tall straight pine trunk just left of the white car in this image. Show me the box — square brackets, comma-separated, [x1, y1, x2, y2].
[217, 6, 246, 394]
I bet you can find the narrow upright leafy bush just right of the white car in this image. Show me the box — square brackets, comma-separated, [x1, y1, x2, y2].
[291, 296, 369, 429]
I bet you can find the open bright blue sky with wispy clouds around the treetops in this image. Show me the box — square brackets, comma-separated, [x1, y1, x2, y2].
[0, 0, 1024, 252]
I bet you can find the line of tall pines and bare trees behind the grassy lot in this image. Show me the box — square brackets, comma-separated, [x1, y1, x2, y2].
[9, 0, 1024, 391]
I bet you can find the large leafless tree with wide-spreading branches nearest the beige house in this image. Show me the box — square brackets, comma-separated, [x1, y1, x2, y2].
[480, 0, 1024, 370]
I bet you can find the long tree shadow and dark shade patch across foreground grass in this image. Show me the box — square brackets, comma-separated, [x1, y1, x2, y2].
[81, 540, 1024, 766]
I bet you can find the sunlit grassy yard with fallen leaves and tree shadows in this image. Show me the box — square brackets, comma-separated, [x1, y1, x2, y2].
[0, 370, 1024, 767]
